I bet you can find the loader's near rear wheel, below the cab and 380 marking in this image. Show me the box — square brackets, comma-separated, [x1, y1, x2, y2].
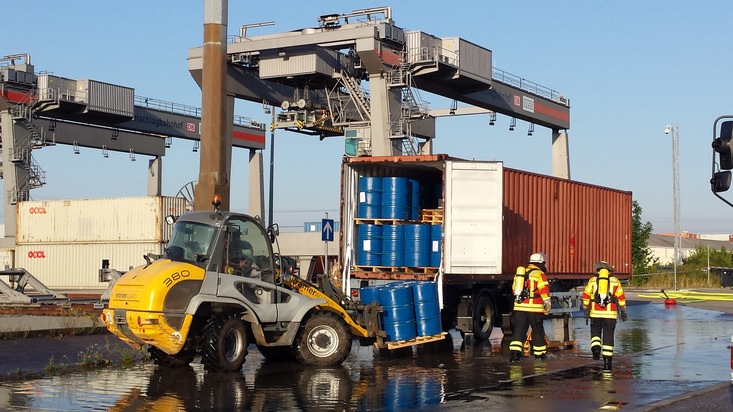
[201, 316, 247, 372]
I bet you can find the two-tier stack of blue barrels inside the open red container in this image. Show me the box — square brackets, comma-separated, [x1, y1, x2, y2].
[356, 176, 442, 267]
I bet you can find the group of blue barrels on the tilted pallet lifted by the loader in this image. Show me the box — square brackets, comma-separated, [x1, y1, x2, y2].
[359, 281, 442, 342]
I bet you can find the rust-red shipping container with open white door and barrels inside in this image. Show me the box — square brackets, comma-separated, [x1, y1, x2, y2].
[341, 155, 632, 285]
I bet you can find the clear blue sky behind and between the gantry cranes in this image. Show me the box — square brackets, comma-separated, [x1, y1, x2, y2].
[0, 0, 733, 234]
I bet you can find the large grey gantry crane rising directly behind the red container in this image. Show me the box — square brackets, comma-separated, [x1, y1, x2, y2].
[189, 7, 570, 178]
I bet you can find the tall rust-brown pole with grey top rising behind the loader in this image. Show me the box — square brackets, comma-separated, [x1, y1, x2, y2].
[193, 0, 231, 210]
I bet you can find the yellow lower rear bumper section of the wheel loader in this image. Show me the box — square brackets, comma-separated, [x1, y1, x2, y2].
[101, 309, 193, 355]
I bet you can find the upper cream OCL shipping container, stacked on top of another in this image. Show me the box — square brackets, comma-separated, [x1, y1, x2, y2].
[16, 196, 186, 245]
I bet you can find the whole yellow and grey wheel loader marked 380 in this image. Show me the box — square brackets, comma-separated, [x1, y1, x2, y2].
[101, 201, 372, 372]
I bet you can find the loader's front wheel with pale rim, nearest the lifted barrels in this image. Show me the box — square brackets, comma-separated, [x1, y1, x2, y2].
[295, 312, 351, 366]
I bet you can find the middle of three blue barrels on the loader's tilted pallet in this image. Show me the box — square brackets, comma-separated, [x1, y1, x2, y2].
[379, 283, 417, 342]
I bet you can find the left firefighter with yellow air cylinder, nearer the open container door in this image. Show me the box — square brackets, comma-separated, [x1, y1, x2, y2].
[509, 253, 551, 362]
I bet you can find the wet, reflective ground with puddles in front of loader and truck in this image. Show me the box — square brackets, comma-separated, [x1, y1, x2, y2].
[0, 304, 733, 411]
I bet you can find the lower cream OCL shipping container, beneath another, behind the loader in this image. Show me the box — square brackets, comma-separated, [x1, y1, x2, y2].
[15, 242, 165, 290]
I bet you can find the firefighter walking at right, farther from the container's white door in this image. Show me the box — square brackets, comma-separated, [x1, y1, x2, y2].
[583, 261, 626, 371]
